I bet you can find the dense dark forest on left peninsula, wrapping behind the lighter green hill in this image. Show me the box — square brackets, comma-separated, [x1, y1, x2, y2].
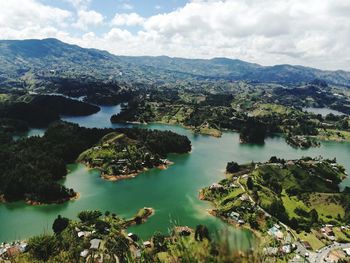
[0, 122, 191, 203]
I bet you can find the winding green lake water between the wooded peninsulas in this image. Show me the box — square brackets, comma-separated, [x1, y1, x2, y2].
[0, 106, 350, 248]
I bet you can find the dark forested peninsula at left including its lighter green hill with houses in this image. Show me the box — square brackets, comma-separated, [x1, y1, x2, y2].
[0, 122, 191, 204]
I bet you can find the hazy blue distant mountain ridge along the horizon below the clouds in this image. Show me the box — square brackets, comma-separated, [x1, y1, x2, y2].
[0, 38, 350, 87]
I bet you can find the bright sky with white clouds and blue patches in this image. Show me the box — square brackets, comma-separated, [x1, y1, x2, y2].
[0, 0, 350, 71]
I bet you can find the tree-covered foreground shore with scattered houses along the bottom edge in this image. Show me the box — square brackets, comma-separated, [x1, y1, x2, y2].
[0, 210, 261, 263]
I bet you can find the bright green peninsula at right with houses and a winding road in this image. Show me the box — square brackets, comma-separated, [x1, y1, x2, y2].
[200, 157, 350, 262]
